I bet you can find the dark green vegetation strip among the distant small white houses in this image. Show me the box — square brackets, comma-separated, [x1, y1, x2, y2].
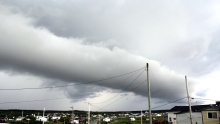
[0, 110, 166, 124]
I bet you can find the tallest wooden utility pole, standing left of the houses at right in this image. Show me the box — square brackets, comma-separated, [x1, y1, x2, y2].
[146, 63, 152, 124]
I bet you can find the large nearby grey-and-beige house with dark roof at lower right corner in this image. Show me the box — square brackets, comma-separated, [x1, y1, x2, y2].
[167, 102, 220, 124]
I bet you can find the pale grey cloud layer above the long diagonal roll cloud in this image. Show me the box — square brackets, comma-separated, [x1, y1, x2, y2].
[4, 0, 219, 75]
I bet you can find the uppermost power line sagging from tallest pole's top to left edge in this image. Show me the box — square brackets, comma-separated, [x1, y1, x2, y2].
[0, 67, 144, 91]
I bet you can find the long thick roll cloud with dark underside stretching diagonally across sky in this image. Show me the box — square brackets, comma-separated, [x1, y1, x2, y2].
[0, 1, 192, 101]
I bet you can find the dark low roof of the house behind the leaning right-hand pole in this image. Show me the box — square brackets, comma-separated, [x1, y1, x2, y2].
[170, 104, 216, 112]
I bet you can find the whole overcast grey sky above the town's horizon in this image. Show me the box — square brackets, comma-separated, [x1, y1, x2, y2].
[0, 0, 220, 111]
